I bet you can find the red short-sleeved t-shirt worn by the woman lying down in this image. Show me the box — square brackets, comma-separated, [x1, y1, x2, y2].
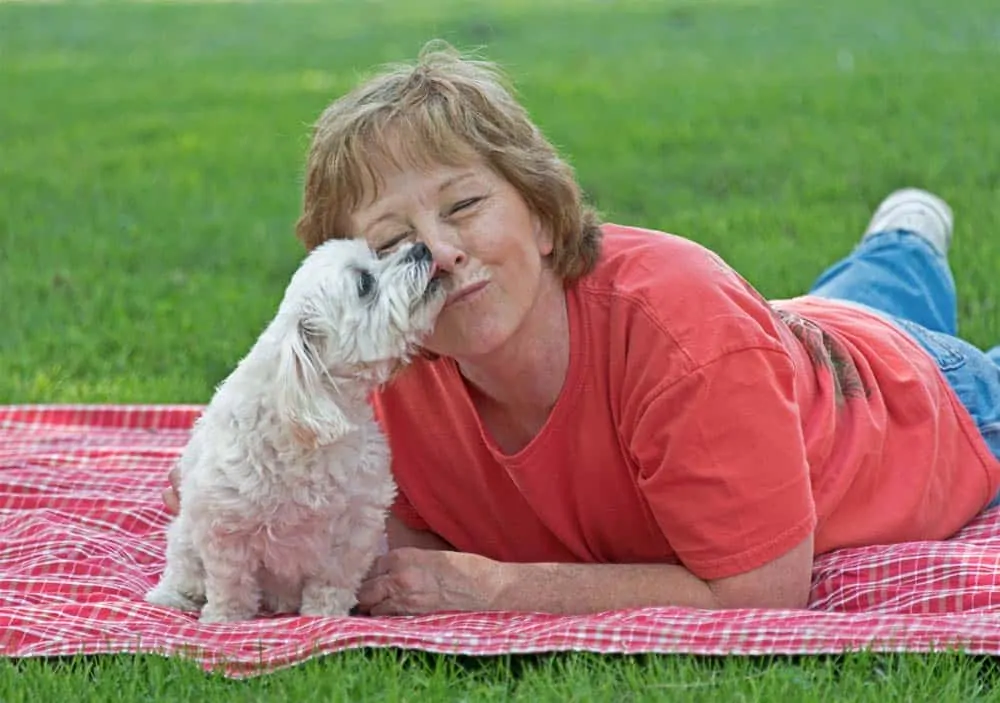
[374, 225, 1000, 579]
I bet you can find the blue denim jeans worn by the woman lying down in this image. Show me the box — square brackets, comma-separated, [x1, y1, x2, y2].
[809, 230, 1000, 507]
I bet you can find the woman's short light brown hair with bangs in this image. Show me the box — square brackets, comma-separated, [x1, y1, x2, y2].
[295, 42, 601, 280]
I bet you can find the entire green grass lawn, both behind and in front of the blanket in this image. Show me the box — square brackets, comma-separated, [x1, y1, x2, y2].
[0, 0, 1000, 702]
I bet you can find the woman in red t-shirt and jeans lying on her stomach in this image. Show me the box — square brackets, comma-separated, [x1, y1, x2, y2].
[166, 46, 1000, 614]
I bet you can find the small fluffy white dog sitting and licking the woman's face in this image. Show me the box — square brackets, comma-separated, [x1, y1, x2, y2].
[146, 240, 446, 622]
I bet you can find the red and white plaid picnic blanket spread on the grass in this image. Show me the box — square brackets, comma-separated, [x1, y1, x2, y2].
[0, 406, 1000, 677]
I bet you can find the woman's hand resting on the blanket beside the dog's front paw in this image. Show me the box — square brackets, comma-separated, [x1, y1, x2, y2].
[358, 547, 503, 615]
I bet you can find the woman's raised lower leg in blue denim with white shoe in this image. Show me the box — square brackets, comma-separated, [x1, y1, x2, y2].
[809, 189, 958, 335]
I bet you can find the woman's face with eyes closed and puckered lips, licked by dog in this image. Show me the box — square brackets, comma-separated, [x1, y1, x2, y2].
[350, 160, 552, 360]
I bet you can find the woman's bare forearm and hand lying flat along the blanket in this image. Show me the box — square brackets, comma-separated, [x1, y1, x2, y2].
[358, 536, 813, 615]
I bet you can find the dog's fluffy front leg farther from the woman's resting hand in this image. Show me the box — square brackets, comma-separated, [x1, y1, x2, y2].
[200, 535, 261, 622]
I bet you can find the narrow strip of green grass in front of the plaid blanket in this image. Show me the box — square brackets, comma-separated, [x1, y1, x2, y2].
[0, 650, 1000, 703]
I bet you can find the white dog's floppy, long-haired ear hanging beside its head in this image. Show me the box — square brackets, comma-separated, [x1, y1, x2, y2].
[275, 320, 353, 446]
